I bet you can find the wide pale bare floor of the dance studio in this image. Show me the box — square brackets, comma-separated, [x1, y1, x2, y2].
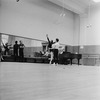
[0, 62, 100, 100]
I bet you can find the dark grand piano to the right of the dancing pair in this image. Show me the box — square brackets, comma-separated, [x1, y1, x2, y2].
[59, 52, 82, 65]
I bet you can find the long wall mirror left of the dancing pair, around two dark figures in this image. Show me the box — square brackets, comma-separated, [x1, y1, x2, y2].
[0, 34, 44, 57]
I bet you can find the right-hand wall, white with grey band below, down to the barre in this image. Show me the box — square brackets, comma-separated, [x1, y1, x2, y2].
[80, 3, 100, 54]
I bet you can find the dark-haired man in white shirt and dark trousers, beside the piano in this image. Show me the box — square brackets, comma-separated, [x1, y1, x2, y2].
[52, 38, 60, 64]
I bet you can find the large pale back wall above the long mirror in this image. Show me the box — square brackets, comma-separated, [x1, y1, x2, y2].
[0, 0, 75, 45]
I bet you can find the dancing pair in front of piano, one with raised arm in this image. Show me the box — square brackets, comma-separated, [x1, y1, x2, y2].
[46, 35, 61, 65]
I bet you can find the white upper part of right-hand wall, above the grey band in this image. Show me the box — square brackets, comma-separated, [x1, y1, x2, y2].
[80, 4, 100, 45]
